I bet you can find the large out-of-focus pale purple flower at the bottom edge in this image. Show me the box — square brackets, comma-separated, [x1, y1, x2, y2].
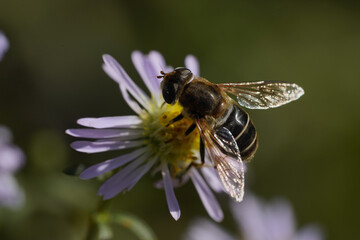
[183, 194, 324, 240]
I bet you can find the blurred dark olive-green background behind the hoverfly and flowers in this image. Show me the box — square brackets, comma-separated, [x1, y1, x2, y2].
[0, 0, 360, 239]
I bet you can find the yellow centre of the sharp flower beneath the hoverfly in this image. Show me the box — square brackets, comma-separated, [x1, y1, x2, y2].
[141, 97, 200, 175]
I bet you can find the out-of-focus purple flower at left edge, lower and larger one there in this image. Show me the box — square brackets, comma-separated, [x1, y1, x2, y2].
[0, 126, 25, 208]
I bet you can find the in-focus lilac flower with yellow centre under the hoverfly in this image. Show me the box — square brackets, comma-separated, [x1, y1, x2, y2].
[66, 51, 223, 221]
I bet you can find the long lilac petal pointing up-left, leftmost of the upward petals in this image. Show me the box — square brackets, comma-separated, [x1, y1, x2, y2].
[103, 54, 150, 110]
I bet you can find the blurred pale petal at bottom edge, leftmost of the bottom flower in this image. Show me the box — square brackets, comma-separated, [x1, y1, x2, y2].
[183, 219, 235, 240]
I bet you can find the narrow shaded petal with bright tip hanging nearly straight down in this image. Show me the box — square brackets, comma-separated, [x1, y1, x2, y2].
[161, 162, 181, 221]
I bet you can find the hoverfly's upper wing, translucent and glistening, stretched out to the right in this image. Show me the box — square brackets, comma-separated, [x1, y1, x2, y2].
[218, 81, 304, 109]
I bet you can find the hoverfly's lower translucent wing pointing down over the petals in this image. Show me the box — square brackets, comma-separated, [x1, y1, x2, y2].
[196, 119, 245, 202]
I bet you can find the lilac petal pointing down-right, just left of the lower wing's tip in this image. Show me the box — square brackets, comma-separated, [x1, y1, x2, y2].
[190, 168, 224, 222]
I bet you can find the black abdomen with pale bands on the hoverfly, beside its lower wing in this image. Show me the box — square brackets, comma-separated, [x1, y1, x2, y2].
[221, 104, 258, 161]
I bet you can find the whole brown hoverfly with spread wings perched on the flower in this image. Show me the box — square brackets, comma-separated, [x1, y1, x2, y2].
[158, 67, 304, 202]
